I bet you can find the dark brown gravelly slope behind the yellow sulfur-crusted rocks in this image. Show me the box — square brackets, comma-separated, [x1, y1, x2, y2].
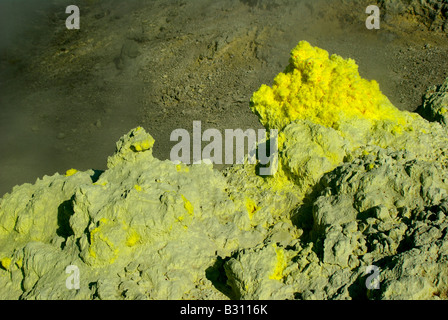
[0, 0, 448, 194]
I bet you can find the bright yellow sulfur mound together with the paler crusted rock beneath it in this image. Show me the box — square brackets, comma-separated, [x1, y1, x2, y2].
[251, 41, 448, 192]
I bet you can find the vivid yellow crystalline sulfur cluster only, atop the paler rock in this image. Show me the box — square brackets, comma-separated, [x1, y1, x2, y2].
[251, 41, 405, 129]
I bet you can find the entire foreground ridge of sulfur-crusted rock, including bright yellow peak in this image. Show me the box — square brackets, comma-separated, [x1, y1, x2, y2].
[0, 41, 448, 299]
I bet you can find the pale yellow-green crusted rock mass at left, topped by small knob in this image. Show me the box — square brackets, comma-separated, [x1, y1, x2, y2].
[0, 128, 300, 299]
